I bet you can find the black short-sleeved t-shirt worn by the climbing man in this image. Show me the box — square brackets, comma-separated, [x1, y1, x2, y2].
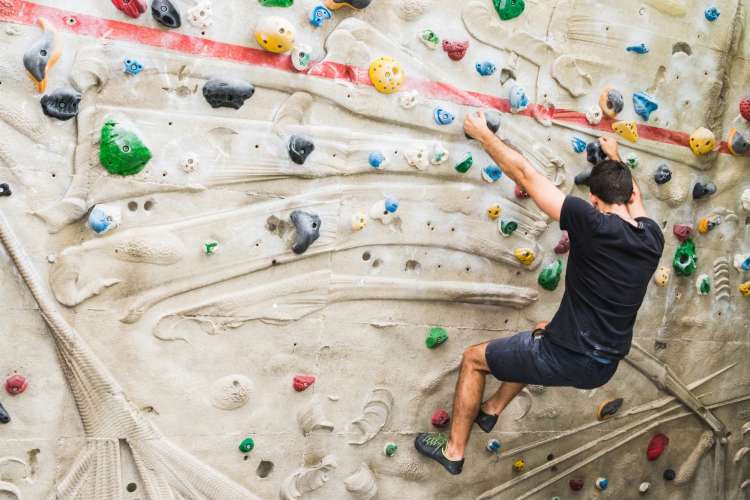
[546, 196, 664, 359]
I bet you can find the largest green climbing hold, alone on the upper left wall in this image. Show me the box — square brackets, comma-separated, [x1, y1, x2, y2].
[99, 120, 151, 175]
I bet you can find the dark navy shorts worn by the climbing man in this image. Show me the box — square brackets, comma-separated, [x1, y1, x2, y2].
[484, 332, 618, 389]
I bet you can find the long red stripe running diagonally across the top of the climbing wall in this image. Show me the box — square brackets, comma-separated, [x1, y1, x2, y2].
[0, 0, 750, 155]
